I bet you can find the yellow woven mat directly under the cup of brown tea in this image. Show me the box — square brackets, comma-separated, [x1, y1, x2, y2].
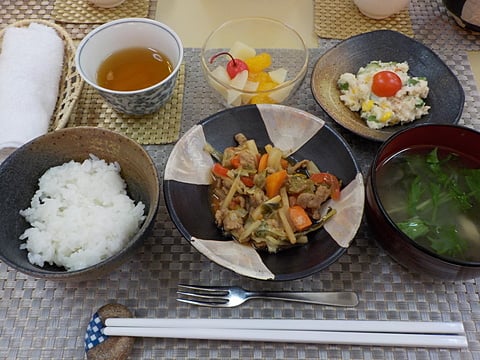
[66, 64, 185, 145]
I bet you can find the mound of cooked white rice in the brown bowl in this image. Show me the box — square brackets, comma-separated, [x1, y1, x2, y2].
[20, 155, 145, 270]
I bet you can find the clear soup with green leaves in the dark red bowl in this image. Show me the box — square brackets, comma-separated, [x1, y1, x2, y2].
[376, 148, 480, 261]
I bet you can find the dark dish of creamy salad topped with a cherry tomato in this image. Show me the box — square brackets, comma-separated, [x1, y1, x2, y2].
[311, 30, 465, 142]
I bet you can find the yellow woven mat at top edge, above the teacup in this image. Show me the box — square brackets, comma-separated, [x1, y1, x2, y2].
[52, 0, 149, 24]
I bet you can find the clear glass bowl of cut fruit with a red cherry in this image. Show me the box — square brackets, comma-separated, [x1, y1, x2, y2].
[201, 17, 308, 107]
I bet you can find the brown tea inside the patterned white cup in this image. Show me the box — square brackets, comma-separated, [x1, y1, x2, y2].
[97, 47, 173, 91]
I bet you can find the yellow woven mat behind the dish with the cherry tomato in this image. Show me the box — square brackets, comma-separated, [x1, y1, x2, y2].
[314, 0, 414, 39]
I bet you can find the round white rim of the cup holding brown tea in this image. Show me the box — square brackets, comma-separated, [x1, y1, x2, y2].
[75, 18, 183, 95]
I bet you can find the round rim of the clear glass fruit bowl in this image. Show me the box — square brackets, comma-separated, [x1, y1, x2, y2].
[201, 16, 308, 95]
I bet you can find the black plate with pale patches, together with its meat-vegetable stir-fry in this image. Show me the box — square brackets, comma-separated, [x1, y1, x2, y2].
[163, 104, 365, 281]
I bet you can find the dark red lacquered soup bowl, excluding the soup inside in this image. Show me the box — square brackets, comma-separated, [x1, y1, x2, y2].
[365, 124, 480, 280]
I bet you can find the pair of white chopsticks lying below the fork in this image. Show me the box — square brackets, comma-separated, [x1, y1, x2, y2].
[103, 318, 468, 348]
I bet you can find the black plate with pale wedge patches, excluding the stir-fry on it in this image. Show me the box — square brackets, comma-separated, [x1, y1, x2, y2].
[163, 104, 364, 280]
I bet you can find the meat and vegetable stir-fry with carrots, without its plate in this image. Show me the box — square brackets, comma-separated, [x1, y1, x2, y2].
[205, 133, 341, 252]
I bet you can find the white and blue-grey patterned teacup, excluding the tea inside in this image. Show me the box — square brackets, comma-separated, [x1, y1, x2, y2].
[75, 18, 183, 115]
